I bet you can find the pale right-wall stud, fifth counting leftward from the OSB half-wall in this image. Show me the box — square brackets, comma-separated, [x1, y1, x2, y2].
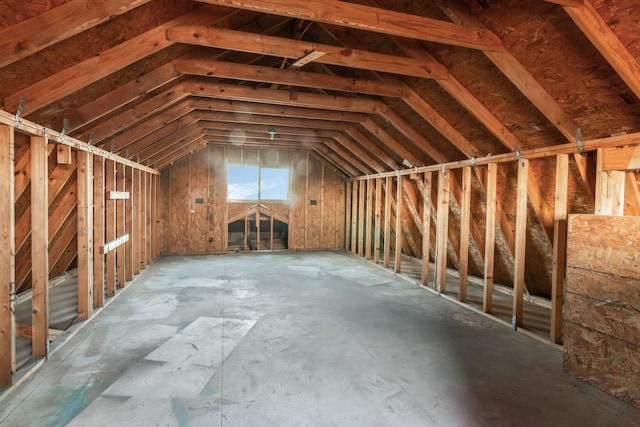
[436, 171, 451, 292]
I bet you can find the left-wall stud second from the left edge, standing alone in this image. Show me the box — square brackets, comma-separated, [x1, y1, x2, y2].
[31, 136, 49, 357]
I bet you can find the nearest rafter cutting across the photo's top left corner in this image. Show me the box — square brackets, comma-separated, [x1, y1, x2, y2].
[0, 0, 149, 68]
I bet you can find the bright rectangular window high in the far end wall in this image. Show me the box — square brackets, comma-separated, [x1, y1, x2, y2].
[227, 165, 289, 200]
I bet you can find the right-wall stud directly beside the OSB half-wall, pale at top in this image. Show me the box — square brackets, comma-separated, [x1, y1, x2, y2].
[550, 154, 569, 344]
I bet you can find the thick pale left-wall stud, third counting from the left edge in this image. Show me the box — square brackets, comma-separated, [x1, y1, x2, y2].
[76, 151, 94, 320]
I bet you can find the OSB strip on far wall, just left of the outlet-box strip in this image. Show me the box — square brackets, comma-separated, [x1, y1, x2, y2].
[169, 158, 189, 253]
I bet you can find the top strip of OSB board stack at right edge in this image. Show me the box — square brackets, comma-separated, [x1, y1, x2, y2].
[567, 215, 640, 278]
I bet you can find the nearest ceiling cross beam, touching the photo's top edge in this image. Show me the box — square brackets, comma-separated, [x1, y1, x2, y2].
[199, 0, 501, 52]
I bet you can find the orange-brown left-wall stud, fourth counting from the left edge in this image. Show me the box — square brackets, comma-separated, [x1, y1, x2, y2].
[93, 156, 106, 308]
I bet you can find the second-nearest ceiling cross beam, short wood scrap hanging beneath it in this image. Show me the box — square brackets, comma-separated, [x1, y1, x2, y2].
[167, 24, 447, 79]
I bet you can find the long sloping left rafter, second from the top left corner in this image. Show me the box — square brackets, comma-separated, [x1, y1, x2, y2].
[4, 8, 234, 115]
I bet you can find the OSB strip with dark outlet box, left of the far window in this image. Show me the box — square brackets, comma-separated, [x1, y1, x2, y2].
[188, 150, 209, 252]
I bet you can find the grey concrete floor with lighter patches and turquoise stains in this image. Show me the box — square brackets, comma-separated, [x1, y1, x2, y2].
[0, 252, 640, 426]
